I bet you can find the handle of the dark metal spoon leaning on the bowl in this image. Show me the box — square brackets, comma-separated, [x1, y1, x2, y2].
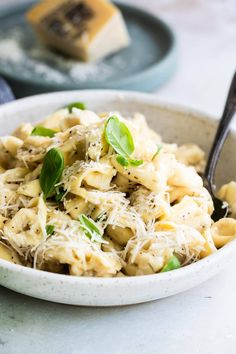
[205, 72, 236, 185]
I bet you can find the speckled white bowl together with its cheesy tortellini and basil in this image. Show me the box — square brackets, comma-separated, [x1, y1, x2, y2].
[0, 90, 236, 306]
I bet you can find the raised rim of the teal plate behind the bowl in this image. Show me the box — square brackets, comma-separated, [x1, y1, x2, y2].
[0, 1, 177, 91]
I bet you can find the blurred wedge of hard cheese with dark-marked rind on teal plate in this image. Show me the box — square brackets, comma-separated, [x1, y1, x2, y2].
[27, 0, 130, 61]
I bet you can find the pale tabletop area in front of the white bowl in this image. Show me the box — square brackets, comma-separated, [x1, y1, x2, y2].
[0, 259, 236, 354]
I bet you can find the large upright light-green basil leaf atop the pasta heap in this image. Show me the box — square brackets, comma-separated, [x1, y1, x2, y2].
[105, 116, 143, 166]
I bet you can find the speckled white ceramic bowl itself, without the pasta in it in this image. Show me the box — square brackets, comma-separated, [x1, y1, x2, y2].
[0, 90, 236, 306]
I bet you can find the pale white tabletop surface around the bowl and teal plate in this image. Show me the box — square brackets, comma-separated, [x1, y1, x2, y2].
[0, 0, 236, 354]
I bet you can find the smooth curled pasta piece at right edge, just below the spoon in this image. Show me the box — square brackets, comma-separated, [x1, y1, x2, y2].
[211, 218, 236, 248]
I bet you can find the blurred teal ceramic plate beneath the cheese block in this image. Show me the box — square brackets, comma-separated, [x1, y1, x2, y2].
[0, 2, 176, 97]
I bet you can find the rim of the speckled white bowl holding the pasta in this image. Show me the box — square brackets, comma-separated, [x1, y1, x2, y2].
[0, 90, 236, 287]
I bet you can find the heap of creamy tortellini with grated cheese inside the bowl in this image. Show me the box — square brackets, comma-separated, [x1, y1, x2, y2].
[0, 105, 236, 277]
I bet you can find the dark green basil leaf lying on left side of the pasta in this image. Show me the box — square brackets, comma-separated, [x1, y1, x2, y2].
[39, 148, 64, 199]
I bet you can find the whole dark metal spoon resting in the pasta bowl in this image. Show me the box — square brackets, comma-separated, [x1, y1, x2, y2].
[203, 72, 236, 221]
